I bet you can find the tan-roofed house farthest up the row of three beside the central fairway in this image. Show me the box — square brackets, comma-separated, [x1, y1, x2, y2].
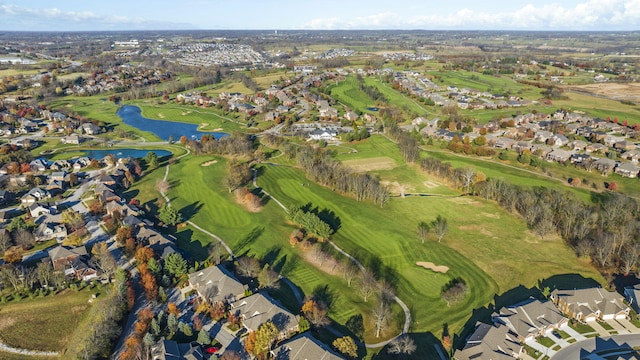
[182, 265, 246, 303]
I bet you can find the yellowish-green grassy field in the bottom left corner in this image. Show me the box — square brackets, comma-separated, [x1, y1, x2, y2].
[0, 290, 97, 352]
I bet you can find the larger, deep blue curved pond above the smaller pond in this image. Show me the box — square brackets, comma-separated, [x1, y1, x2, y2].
[116, 105, 229, 141]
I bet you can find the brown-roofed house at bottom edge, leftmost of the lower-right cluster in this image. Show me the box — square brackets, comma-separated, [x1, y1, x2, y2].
[453, 322, 522, 360]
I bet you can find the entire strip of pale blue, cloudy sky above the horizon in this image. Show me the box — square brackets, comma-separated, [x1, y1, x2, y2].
[0, 0, 640, 31]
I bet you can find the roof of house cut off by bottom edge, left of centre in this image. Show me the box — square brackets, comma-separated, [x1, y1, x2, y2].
[271, 332, 344, 360]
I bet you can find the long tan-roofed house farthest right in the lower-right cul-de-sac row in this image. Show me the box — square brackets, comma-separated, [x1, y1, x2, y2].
[550, 288, 629, 322]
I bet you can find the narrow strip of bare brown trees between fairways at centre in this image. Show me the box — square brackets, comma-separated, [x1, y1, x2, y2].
[296, 145, 389, 207]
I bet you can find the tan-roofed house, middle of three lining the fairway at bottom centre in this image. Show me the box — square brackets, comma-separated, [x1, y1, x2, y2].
[231, 293, 299, 340]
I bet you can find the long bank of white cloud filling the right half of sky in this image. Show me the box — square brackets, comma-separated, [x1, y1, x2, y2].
[304, 0, 640, 30]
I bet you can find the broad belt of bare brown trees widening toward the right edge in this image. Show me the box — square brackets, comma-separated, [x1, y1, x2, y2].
[420, 153, 640, 274]
